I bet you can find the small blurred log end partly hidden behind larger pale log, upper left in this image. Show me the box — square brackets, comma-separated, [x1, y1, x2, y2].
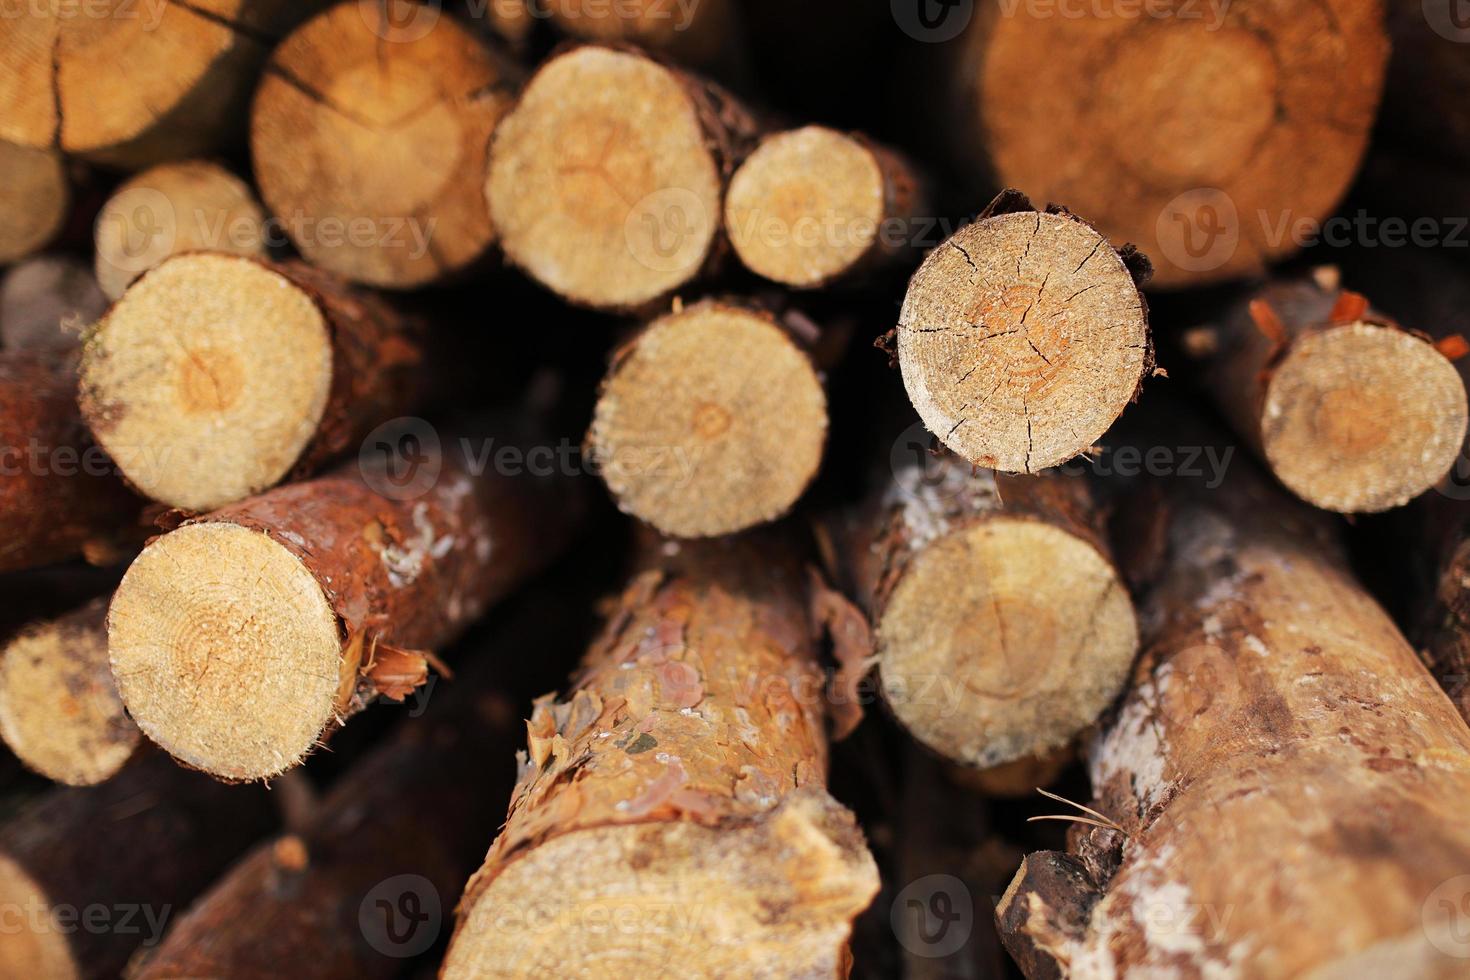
[93, 160, 266, 300]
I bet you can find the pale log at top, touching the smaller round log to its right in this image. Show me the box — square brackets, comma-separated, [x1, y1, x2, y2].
[485, 46, 756, 310]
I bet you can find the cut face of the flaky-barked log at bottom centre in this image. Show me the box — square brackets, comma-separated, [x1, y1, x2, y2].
[444, 789, 878, 980]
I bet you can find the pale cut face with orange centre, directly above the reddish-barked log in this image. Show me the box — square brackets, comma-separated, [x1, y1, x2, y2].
[81, 253, 332, 511]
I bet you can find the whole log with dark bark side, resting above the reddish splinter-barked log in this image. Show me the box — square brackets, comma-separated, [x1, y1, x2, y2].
[81, 253, 423, 511]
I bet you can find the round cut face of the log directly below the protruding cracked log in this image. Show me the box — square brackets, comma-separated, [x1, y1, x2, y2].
[878, 517, 1138, 767]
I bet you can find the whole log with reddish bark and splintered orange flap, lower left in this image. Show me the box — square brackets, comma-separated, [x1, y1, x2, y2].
[107, 445, 581, 780]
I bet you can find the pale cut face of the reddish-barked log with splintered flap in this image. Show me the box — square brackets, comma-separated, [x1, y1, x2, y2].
[107, 523, 343, 780]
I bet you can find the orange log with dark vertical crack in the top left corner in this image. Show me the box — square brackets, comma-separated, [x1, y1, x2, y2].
[0, 0, 325, 169]
